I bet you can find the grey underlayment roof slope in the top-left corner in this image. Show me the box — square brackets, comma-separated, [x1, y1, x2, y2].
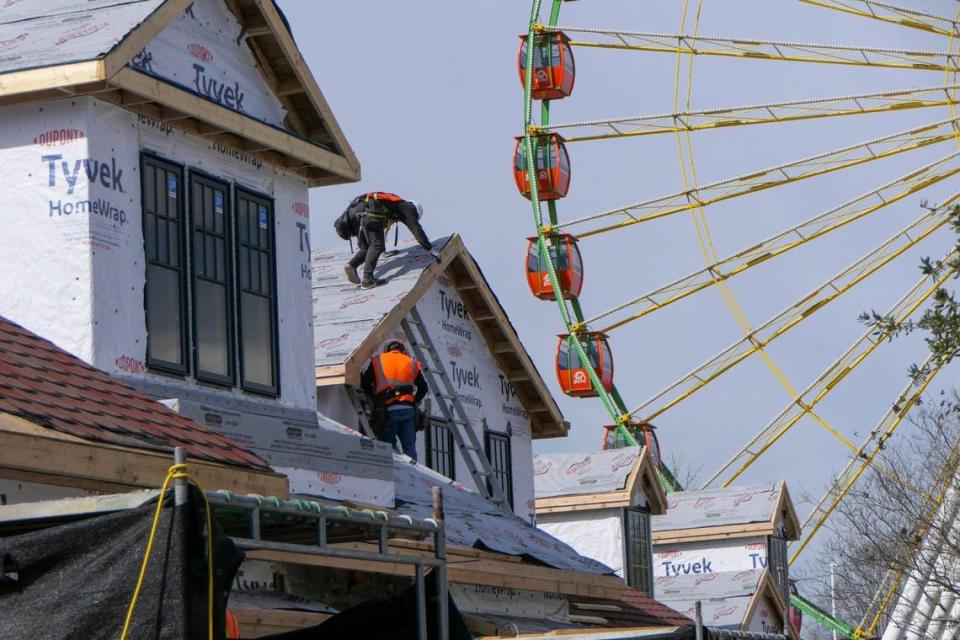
[0, 0, 163, 73]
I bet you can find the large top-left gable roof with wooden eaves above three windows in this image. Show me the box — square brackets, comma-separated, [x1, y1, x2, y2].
[0, 0, 360, 186]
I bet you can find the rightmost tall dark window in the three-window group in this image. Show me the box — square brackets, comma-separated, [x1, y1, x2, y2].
[236, 189, 278, 395]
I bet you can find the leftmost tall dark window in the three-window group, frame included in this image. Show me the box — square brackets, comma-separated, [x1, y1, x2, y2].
[141, 155, 188, 375]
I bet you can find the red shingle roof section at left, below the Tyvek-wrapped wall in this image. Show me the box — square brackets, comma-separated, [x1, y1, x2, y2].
[0, 316, 269, 469]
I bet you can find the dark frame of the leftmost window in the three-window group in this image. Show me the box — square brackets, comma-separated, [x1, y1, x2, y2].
[140, 151, 192, 377]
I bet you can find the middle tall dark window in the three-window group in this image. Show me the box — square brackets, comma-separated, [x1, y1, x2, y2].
[190, 173, 234, 385]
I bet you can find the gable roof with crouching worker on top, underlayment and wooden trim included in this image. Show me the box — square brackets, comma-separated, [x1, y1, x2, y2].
[312, 235, 570, 438]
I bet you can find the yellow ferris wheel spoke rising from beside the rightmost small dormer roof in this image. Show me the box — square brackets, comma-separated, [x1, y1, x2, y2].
[790, 355, 946, 564]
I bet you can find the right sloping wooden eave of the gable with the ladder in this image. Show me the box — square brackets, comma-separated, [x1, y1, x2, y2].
[454, 236, 570, 439]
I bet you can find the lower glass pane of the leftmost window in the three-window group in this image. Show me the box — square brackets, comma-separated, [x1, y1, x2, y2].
[147, 264, 183, 365]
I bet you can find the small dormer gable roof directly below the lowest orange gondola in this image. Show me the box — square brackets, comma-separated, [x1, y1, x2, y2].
[533, 447, 667, 515]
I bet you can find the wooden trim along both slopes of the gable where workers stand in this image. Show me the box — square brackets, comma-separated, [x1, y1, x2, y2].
[328, 234, 570, 439]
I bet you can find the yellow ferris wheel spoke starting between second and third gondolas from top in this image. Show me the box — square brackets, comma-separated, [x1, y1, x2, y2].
[556, 118, 958, 238]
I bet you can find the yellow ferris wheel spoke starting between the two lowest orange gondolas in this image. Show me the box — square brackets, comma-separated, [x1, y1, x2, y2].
[630, 198, 960, 422]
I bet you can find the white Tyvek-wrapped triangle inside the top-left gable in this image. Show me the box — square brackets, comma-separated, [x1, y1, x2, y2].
[130, 0, 286, 127]
